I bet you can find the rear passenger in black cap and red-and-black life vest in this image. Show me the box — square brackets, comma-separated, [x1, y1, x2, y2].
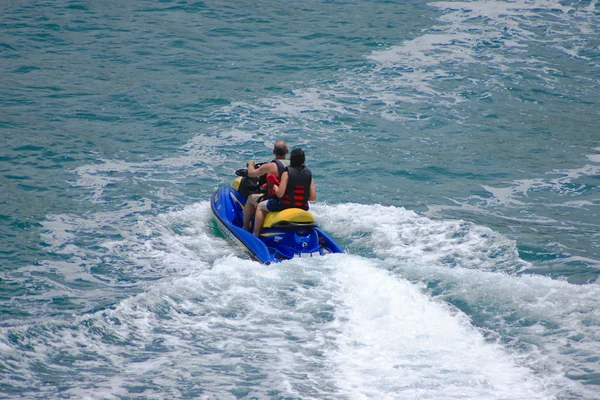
[254, 149, 317, 236]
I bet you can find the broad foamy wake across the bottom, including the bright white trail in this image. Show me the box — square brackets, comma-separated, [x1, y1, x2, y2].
[16, 255, 564, 399]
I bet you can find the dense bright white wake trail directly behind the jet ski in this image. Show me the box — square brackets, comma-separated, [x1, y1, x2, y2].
[329, 257, 551, 399]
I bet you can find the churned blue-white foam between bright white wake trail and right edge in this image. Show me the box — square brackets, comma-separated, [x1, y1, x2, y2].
[388, 259, 600, 398]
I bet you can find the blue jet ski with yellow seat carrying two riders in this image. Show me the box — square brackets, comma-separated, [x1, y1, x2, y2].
[210, 164, 343, 264]
